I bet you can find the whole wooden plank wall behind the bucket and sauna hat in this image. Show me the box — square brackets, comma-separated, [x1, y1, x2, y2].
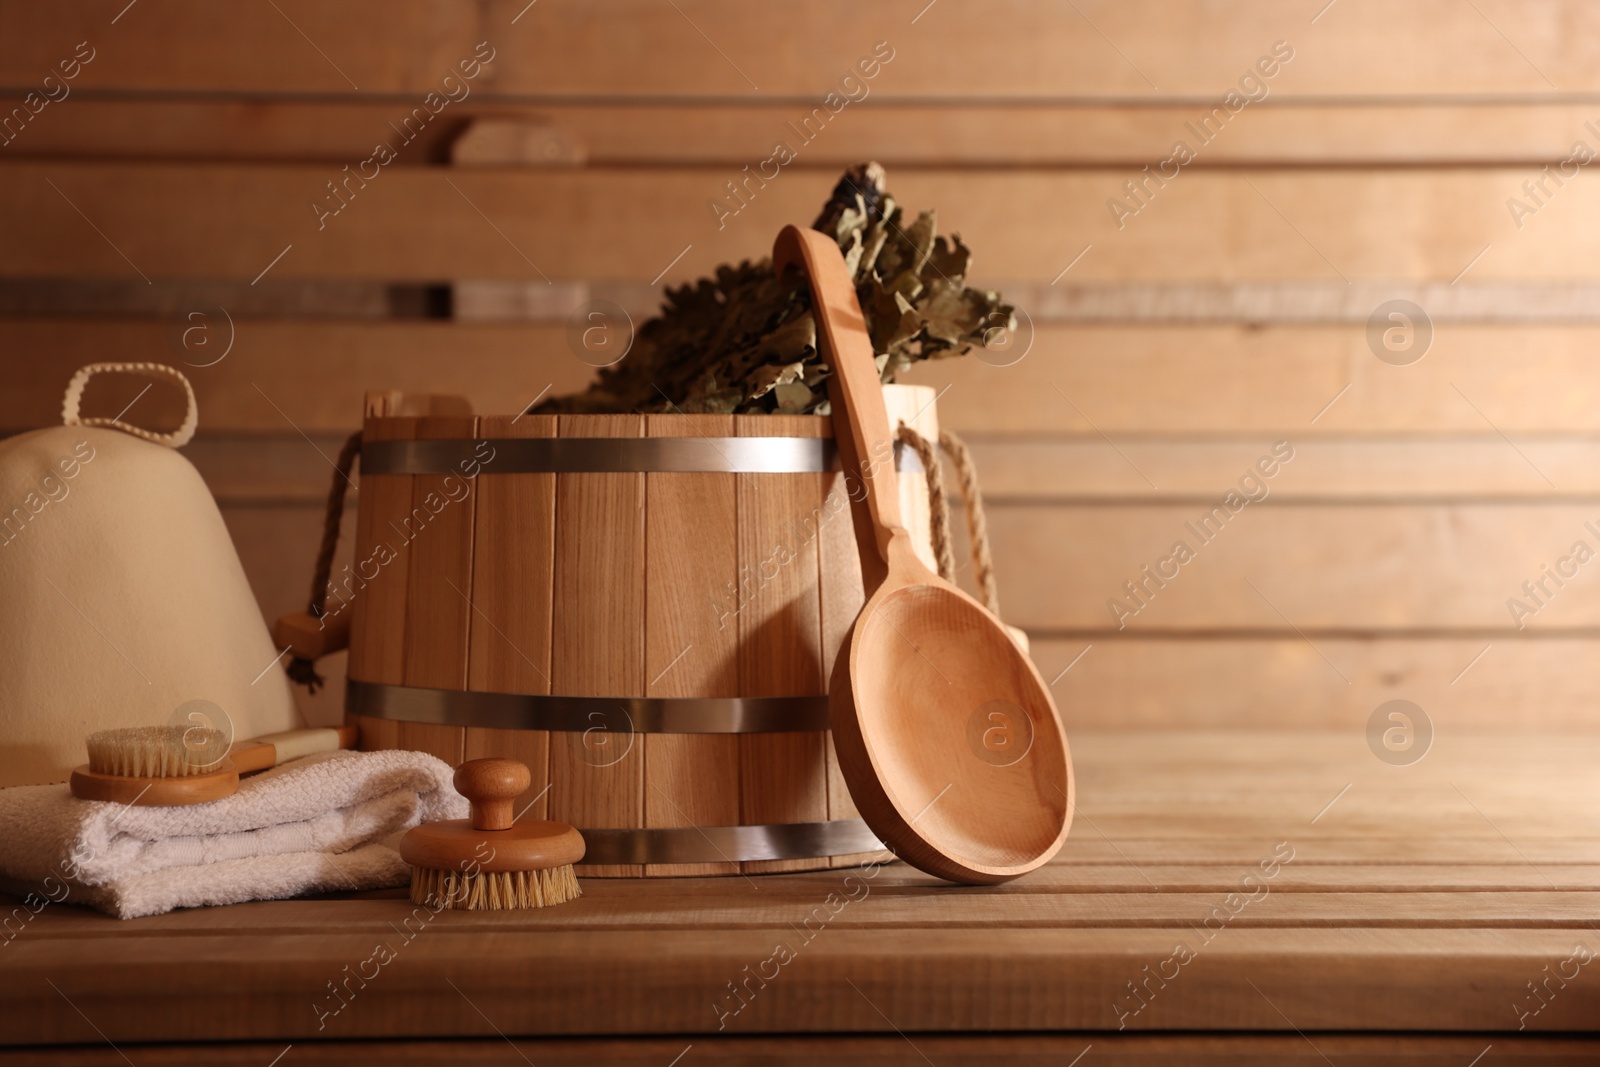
[0, 0, 1600, 733]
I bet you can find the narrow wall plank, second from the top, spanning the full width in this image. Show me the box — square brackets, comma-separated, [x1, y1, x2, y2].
[9, 99, 1595, 164]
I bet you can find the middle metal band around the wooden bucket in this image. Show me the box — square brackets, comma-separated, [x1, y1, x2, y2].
[344, 678, 827, 734]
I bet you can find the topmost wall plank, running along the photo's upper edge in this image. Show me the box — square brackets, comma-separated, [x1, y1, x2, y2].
[0, 0, 1600, 99]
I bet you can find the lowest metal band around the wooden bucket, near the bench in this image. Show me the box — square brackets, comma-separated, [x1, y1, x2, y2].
[581, 819, 883, 864]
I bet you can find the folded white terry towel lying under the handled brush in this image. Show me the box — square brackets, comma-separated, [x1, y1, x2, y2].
[0, 750, 467, 918]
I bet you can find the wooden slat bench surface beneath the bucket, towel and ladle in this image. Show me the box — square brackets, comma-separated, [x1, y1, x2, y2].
[0, 729, 1600, 1064]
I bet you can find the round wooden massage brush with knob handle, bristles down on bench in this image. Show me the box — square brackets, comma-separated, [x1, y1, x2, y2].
[400, 760, 584, 912]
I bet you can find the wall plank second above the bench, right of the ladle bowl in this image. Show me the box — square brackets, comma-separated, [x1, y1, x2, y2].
[989, 501, 1600, 640]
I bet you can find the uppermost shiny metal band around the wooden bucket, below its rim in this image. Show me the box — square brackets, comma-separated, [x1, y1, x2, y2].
[362, 437, 923, 474]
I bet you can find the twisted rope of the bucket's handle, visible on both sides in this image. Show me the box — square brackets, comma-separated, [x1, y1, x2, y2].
[276, 422, 1000, 693]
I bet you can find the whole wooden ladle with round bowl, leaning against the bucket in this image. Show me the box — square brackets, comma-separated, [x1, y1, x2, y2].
[773, 226, 1074, 883]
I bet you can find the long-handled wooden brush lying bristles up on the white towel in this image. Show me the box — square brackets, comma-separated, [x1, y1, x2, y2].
[72, 725, 355, 808]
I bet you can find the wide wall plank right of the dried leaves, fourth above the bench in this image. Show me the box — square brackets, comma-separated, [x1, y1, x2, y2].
[907, 323, 1600, 435]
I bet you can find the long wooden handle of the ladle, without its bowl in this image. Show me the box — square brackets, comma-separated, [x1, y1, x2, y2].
[773, 226, 909, 566]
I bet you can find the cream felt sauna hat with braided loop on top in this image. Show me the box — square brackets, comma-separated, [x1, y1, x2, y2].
[0, 363, 298, 787]
